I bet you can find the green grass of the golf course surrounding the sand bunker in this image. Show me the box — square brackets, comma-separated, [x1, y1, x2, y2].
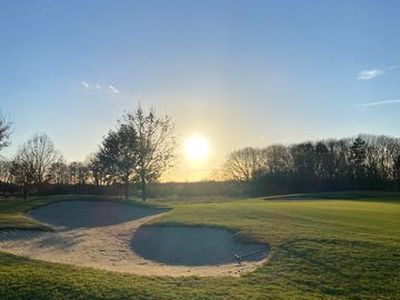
[0, 193, 400, 299]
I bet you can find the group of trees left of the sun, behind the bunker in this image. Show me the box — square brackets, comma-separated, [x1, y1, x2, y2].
[0, 106, 176, 200]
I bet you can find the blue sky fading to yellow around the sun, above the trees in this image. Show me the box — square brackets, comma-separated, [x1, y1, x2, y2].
[0, 0, 400, 181]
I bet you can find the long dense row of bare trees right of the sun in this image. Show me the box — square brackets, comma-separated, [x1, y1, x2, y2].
[223, 135, 400, 194]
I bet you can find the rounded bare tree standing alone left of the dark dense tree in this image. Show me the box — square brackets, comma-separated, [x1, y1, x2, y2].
[11, 134, 61, 199]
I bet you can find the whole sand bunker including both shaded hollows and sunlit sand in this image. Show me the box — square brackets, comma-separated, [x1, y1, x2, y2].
[0, 201, 266, 276]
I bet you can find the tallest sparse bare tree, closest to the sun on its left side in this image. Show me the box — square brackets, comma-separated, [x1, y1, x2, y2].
[121, 106, 176, 201]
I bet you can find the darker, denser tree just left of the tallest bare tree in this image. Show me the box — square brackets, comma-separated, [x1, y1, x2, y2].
[98, 123, 139, 198]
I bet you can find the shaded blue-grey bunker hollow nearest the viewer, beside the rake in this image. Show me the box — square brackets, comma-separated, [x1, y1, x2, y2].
[131, 226, 268, 266]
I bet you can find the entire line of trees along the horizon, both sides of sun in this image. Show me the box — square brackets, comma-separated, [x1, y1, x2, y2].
[0, 106, 400, 200]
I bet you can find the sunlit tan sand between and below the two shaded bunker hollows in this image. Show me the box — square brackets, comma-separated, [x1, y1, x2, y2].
[0, 201, 265, 277]
